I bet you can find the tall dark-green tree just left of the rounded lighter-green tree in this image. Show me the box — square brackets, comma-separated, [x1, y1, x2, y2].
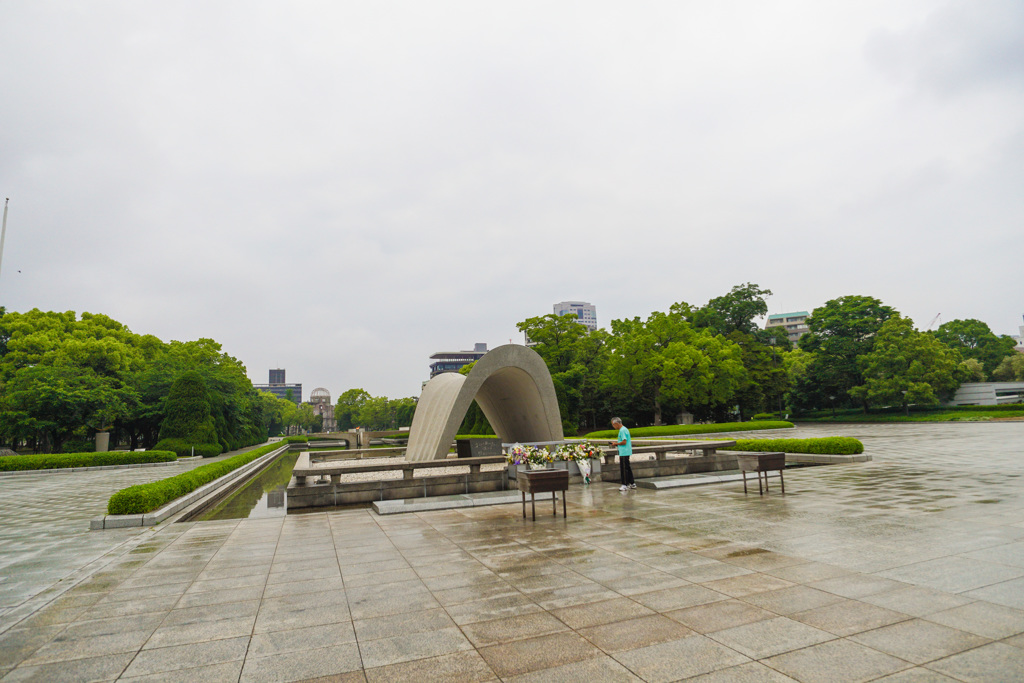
[791, 296, 899, 408]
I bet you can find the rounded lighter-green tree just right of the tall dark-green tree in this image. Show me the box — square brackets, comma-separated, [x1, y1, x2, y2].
[850, 315, 967, 405]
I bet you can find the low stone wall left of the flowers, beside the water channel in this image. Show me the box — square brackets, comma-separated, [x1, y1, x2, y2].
[288, 463, 509, 510]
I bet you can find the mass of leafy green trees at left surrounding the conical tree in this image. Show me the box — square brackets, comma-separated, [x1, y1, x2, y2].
[0, 309, 269, 451]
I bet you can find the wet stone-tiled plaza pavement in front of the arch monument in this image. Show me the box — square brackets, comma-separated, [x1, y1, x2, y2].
[0, 423, 1024, 683]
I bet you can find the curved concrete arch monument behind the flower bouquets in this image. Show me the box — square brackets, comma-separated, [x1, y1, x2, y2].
[406, 344, 562, 461]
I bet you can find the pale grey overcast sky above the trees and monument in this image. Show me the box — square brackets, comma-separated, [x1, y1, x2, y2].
[0, 0, 1024, 398]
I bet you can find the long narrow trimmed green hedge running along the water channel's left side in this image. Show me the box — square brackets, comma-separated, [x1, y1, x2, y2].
[106, 437, 290, 515]
